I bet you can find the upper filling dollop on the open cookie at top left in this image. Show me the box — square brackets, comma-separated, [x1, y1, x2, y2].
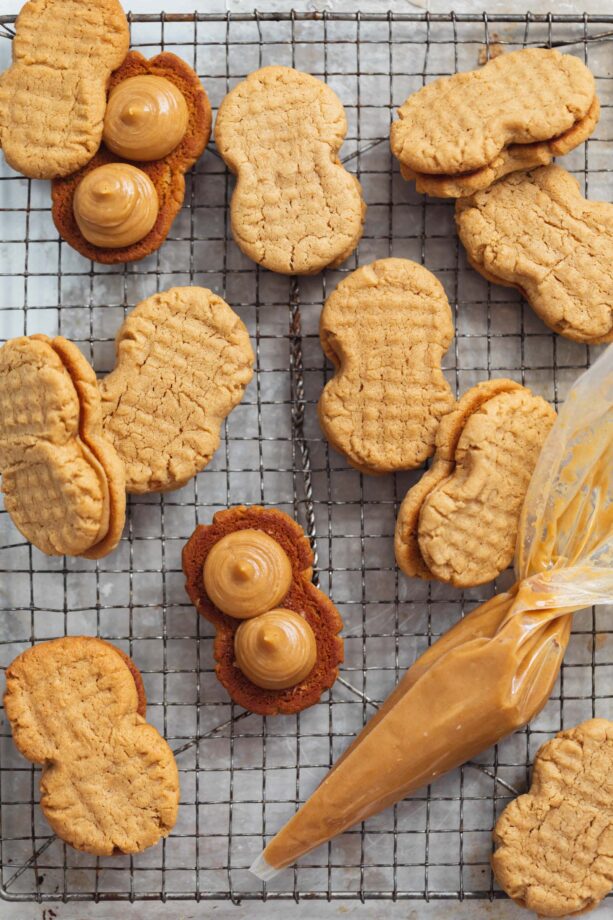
[103, 74, 189, 161]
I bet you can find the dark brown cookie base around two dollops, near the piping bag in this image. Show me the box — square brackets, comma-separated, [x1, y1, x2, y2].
[183, 505, 343, 715]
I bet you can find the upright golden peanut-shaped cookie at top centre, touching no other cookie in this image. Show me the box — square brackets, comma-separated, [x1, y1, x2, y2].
[215, 67, 366, 275]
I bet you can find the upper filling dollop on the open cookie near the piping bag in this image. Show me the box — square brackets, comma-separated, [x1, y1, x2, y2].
[203, 529, 292, 620]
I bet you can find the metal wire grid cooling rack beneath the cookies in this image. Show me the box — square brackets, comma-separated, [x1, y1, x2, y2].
[0, 13, 613, 902]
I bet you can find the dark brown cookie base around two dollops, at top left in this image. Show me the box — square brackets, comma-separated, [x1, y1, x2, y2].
[51, 51, 211, 265]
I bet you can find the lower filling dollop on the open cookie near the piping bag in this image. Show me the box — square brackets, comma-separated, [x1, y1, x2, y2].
[234, 607, 317, 690]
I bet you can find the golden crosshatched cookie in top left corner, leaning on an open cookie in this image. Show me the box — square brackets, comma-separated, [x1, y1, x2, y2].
[0, 0, 129, 179]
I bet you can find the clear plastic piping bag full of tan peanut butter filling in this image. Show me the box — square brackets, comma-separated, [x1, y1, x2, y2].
[251, 345, 613, 880]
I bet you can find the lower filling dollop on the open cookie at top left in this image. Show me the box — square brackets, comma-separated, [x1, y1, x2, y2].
[73, 163, 159, 249]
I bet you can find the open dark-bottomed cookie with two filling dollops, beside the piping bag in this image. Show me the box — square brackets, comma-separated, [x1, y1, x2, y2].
[182, 505, 343, 716]
